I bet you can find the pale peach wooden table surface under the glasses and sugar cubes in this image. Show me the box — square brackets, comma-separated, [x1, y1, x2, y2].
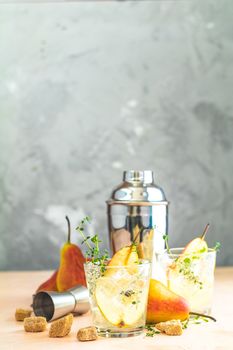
[0, 267, 233, 350]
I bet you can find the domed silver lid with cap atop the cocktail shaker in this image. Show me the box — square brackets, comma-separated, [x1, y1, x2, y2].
[107, 170, 168, 205]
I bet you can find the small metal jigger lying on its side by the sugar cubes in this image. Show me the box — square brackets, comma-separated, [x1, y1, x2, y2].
[32, 286, 90, 321]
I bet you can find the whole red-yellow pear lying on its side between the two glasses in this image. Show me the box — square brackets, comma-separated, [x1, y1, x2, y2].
[146, 279, 190, 323]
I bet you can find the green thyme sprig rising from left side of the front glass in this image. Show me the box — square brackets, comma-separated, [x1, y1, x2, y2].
[76, 216, 109, 271]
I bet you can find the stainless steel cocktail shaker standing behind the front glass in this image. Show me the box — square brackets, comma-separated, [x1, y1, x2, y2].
[107, 170, 168, 274]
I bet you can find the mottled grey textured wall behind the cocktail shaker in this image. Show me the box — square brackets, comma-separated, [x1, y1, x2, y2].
[0, 0, 233, 270]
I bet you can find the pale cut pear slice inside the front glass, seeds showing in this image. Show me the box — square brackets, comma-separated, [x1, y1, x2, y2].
[95, 277, 147, 327]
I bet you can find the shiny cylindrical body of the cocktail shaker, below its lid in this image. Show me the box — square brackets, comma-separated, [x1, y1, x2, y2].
[108, 203, 168, 260]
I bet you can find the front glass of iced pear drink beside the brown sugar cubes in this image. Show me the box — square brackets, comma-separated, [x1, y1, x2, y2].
[84, 258, 151, 337]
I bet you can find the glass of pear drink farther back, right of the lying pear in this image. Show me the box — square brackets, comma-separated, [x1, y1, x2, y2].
[156, 227, 218, 315]
